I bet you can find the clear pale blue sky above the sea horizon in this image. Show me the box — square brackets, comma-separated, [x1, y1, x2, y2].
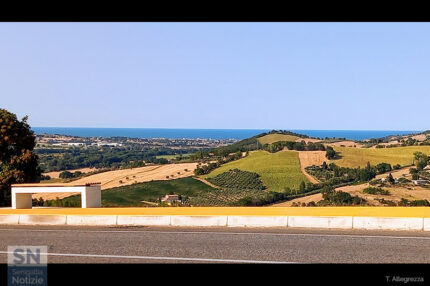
[0, 23, 430, 130]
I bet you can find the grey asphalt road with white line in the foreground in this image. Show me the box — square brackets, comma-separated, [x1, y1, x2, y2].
[0, 226, 430, 263]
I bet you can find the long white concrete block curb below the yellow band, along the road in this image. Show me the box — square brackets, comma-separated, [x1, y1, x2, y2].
[0, 214, 430, 231]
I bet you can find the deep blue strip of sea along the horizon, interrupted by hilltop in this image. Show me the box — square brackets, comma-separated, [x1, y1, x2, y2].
[32, 127, 422, 140]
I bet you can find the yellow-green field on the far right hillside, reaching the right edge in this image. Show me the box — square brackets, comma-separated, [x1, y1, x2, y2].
[330, 146, 430, 168]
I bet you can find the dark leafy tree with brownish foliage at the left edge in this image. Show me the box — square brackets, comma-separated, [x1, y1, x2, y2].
[0, 109, 41, 206]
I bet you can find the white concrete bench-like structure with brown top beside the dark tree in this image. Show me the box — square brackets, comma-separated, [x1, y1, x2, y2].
[12, 184, 101, 209]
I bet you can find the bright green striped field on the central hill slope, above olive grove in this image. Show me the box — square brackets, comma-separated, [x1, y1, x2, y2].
[204, 150, 308, 191]
